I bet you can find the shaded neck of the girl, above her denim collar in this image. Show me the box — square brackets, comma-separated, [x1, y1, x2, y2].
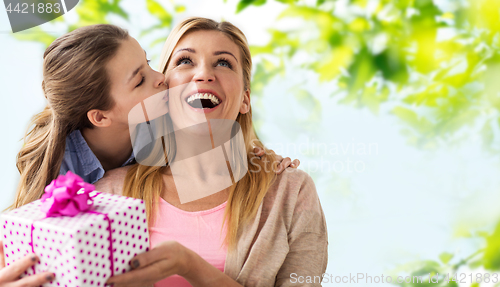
[81, 128, 132, 171]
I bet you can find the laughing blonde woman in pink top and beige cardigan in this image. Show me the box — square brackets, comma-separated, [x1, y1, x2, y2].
[97, 18, 328, 286]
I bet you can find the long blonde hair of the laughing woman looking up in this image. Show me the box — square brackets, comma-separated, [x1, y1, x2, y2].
[123, 17, 276, 251]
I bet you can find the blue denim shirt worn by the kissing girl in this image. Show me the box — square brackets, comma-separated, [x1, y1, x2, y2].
[59, 130, 135, 183]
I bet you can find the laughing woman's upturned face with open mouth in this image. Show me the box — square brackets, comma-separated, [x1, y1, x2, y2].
[165, 30, 250, 128]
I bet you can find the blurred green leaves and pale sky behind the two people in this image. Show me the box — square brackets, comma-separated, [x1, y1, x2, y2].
[0, 0, 500, 286]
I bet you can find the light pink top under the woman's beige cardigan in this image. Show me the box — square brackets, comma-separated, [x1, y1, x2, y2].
[150, 198, 227, 287]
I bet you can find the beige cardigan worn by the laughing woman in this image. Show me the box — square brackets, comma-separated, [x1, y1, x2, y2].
[96, 168, 328, 287]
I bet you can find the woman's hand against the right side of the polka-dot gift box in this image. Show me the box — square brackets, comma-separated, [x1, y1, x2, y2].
[106, 241, 192, 287]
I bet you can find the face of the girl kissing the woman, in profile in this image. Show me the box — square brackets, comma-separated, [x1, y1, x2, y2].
[105, 37, 168, 128]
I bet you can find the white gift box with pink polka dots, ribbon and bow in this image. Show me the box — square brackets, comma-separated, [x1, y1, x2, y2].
[0, 172, 149, 287]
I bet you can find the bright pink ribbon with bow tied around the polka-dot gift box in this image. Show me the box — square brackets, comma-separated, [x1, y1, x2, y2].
[30, 171, 114, 277]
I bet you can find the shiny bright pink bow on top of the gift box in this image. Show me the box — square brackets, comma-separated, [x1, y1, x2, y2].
[41, 171, 95, 217]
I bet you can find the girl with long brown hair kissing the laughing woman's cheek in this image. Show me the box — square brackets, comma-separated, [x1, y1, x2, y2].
[0, 25, 291, 286]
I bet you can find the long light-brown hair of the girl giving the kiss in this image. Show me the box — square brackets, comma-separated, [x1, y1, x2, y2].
[10, 24, 128, 208]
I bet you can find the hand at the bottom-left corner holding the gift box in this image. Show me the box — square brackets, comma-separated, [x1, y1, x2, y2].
[0, 241, 54, 287]
